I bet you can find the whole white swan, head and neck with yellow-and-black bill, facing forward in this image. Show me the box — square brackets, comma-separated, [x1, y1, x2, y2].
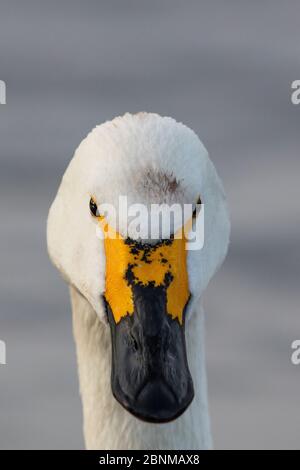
[47, 112, 230, 450]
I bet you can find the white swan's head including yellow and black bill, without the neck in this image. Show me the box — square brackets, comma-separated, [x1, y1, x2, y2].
[47, 113, 230, 422]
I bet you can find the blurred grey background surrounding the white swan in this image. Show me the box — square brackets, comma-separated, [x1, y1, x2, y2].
[0, 0, 300, 449]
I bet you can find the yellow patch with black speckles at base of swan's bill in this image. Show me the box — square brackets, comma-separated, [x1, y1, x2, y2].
[99, 217, 190, 324]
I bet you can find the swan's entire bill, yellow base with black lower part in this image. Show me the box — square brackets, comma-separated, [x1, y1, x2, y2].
[104, 233, 194, 422]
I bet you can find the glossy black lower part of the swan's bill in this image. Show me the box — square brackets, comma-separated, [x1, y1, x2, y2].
[104, 284, 194, 423]
